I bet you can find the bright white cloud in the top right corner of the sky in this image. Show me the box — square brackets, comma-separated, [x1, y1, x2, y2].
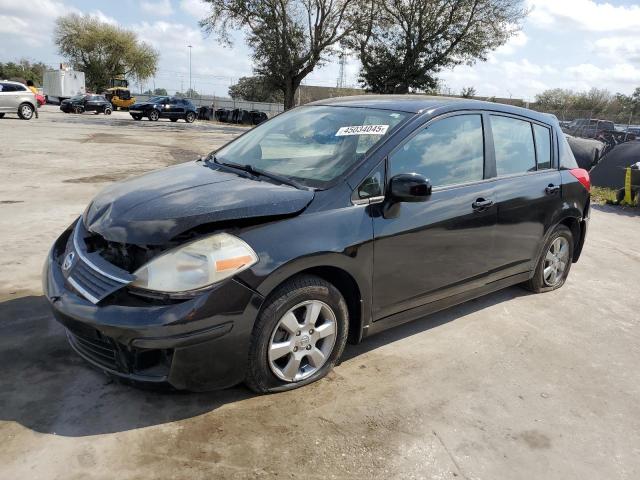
[527, 0, 640, 32]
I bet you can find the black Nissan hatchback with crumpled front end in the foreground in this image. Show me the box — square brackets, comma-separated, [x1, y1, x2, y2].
[43, 96, 590, 392]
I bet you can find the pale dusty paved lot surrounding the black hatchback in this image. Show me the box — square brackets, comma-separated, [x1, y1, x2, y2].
[0, 106, 640, 480]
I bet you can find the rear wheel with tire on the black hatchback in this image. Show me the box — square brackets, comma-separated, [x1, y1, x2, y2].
[524, 225, 575, 293]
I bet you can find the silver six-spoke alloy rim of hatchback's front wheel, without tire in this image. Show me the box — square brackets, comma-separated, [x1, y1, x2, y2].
[268, 300, 337, 382]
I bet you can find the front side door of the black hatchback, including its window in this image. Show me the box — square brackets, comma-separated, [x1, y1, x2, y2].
[372, 113, 497, 321]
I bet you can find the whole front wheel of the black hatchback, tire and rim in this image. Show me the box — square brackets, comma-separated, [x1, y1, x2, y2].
[245, 275, 349, 393]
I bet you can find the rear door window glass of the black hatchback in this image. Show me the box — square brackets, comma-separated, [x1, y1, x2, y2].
[491, 115, 536, 176]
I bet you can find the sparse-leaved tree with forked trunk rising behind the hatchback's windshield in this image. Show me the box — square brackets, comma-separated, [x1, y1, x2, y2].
[200, 0, 364, 109]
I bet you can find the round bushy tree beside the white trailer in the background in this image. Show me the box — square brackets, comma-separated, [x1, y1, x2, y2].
[54, 14, 158, 92]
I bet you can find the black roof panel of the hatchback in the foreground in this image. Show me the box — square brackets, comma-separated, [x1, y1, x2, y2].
[308, 94, 551, 122]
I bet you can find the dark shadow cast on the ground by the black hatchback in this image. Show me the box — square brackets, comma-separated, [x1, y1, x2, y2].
[0, 288, 527, 437]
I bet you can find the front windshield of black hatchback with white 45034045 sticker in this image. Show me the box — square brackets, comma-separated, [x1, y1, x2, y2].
[216, 106, 411, 188]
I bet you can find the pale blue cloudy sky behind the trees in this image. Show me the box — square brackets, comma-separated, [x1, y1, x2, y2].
[0, 0, 640, 101]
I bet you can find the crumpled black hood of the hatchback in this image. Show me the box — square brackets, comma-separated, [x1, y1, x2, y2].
[84, 162, 314, 245]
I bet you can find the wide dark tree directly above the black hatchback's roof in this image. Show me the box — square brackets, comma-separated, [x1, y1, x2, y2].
[349, 0, 527, 93]
